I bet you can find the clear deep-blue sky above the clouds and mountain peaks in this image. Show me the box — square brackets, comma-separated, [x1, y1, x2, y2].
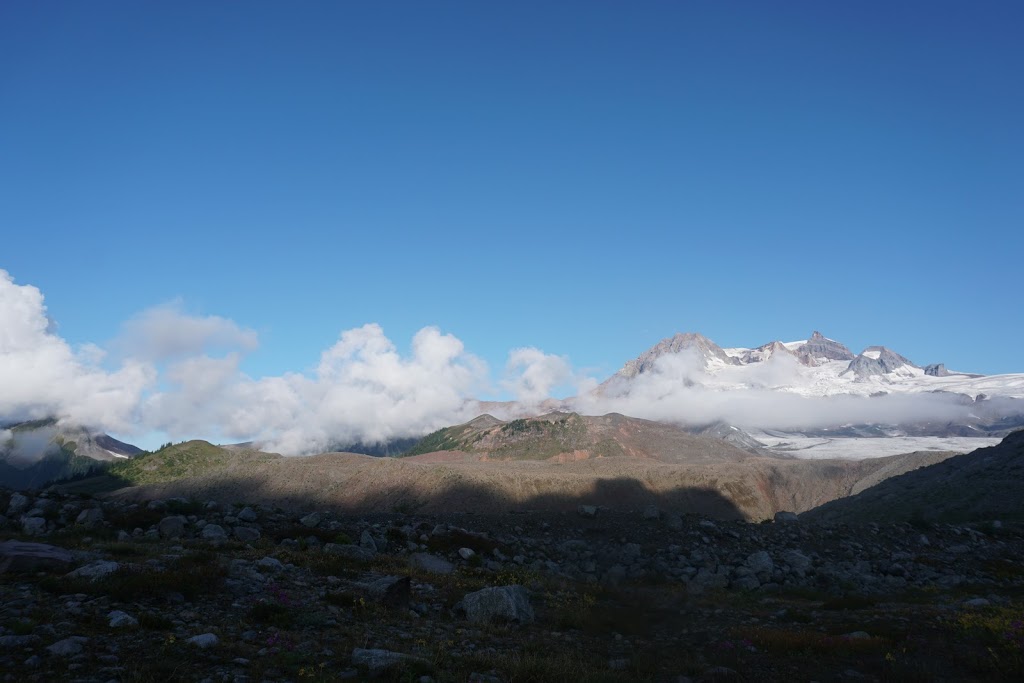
[0, 0, 1024, 377]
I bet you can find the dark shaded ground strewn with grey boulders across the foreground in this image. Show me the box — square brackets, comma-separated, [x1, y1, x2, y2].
[0, 490, 1024, 682]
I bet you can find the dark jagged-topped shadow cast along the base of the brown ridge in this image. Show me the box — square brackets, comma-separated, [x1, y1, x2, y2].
[83, 475, 751, 519]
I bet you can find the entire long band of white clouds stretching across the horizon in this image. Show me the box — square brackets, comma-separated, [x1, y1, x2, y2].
[0, 270, 1020, 455]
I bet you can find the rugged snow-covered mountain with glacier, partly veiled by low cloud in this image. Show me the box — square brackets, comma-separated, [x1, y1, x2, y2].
[585, 332, 1024, 458]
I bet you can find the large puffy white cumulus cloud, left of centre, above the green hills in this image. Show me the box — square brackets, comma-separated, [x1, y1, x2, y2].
[138, 325, 487, 454]
